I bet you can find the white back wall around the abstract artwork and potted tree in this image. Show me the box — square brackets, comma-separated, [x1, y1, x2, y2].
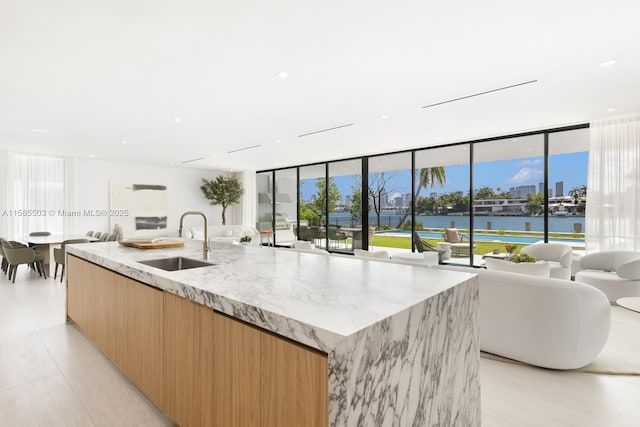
[65, 159, 255, 236]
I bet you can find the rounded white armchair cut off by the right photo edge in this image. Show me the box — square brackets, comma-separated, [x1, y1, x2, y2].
[576, 251, 640, 302]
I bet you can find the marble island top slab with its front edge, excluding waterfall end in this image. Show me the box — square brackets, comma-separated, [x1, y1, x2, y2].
[67, 241, 474, 352]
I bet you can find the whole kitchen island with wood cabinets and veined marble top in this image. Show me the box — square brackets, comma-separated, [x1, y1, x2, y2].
[67, 241, 480, 427]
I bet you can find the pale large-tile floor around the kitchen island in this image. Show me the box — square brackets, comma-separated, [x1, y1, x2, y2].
[0, 266, 640, 427]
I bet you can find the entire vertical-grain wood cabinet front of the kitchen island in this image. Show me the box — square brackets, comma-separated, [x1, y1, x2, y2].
[67, 255, 328, 427]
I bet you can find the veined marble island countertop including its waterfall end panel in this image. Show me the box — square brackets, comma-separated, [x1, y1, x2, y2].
[67, 241, 480, 427]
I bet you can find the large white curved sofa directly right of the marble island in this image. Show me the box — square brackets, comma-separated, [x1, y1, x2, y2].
[432, 265, 611, 369]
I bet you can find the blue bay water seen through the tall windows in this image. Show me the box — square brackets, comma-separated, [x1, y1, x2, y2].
[329, 212, 585, 233]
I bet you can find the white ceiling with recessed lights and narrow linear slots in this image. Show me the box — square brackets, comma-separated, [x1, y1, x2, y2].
[0, 0, 640, 170]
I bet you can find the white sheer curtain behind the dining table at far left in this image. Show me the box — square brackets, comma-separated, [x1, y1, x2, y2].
[2, 153, 65, 239]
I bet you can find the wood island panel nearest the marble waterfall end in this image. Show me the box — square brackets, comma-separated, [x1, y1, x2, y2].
[260, 333, 329, 427]
